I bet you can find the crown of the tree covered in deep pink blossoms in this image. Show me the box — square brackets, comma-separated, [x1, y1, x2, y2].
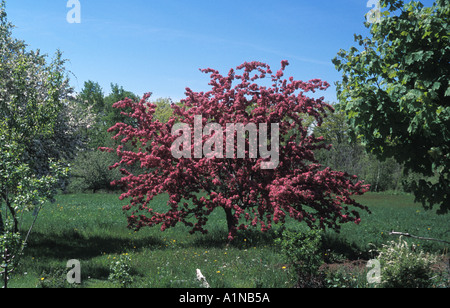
[100, 61, 368, 240]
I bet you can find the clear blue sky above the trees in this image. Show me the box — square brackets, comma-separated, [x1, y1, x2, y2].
[2, 0, 432, 102]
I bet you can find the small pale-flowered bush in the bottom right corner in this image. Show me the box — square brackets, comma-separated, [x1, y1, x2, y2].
[378, 238, 437, 288]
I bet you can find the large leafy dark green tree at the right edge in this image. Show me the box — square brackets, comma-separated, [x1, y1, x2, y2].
[333, 0, 450, 213]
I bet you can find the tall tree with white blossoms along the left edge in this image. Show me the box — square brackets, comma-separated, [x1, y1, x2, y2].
[0, 1, 89, 287]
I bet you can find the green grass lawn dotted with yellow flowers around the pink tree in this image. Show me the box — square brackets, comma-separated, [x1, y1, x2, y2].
[9, 193, 450, 288]
